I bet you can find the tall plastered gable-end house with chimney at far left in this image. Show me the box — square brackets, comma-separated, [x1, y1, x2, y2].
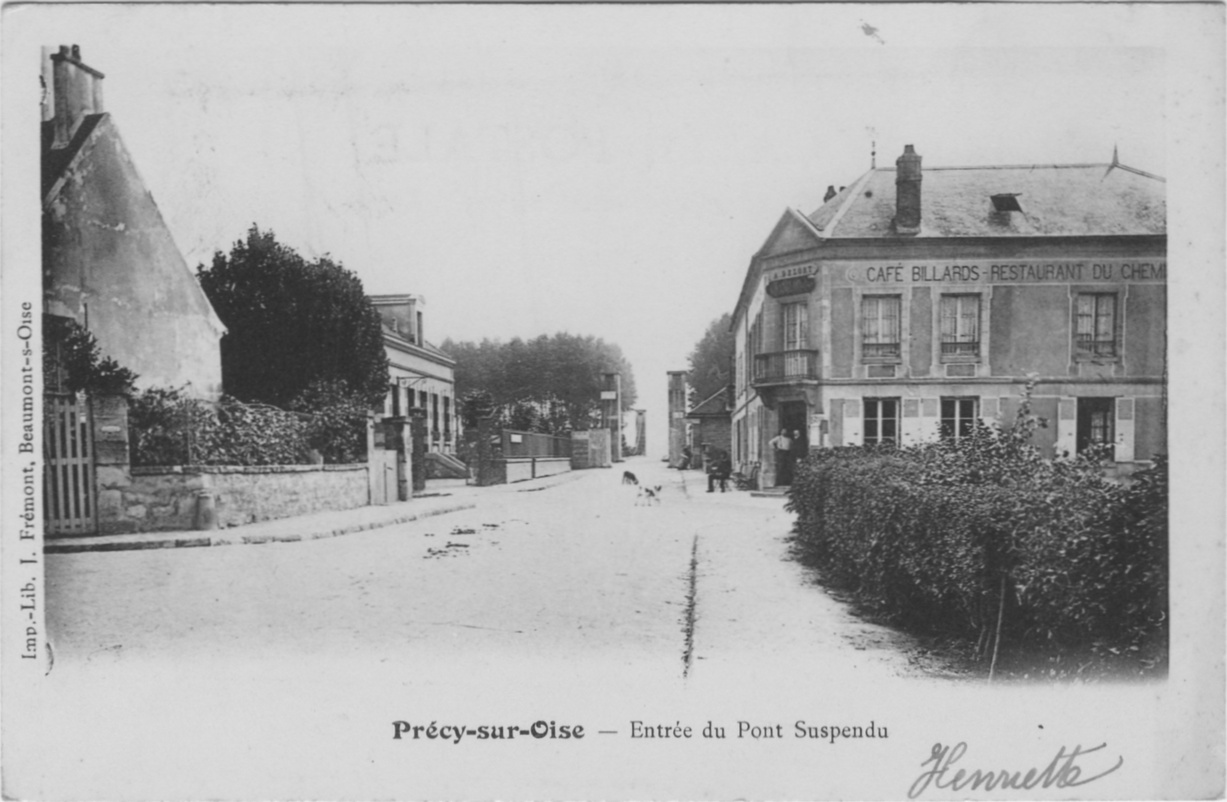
[42, 45, 226, 399]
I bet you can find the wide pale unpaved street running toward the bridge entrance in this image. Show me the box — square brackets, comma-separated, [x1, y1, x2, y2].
[47, 459, 932, 682]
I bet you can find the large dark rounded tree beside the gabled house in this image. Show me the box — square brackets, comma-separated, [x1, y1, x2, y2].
[196, 226, 388, 406]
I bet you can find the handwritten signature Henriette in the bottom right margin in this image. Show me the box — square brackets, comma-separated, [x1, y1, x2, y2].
[908, 743, 1125, 800]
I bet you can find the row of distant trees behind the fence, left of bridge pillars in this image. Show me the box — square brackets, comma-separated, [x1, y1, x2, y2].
[440, 334, 636, 434]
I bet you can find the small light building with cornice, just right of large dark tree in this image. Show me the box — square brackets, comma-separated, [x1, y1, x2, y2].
[369, 296, 460, 454]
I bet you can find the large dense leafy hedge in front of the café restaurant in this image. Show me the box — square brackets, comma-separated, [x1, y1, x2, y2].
[788, 402, 1167, 671]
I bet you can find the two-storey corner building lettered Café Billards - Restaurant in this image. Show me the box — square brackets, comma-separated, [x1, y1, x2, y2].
[733, 145, 1167, 486]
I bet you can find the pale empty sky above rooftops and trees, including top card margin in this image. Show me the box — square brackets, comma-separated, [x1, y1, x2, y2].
[5, 5, 1179, 455]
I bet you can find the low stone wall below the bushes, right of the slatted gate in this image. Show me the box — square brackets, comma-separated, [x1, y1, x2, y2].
[98, 465, 369, 535]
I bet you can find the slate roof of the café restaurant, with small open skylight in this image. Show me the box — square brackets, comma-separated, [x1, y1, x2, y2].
[806, 162, 1167, 239]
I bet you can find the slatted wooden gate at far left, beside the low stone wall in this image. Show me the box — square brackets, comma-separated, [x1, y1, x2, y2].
[43, 395, 97, 535]
